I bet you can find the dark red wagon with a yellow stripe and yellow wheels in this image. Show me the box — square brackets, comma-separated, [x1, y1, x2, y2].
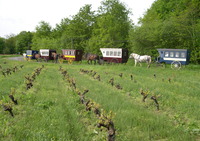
[62, 49, 83, 63]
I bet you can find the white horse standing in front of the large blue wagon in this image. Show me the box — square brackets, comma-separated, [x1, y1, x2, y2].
[129, 53, 151, 68]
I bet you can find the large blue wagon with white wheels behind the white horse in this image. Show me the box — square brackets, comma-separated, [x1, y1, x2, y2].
[157, 49, 190, 69]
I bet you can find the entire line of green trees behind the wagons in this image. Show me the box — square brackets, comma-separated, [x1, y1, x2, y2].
[0, 0, 200, 64]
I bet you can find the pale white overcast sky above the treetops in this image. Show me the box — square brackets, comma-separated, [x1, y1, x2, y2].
[0, 0, 155, 38]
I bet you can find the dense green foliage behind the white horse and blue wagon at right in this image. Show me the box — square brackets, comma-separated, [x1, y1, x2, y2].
[130, 0, 200, 63]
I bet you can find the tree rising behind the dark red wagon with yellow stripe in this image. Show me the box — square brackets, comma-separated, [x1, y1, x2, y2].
[59, 5, 95, 50]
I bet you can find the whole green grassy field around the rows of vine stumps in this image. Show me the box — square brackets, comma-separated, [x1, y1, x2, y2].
[0, 58, 200, 141]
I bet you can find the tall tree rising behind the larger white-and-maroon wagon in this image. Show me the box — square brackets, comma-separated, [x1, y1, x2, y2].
[88, 0, 131, 53]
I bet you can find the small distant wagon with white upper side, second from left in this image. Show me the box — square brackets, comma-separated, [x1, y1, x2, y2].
[40, 49, 56, 61]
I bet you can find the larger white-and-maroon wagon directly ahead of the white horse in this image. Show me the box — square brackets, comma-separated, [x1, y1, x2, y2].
[100, 48, 129, 63]
